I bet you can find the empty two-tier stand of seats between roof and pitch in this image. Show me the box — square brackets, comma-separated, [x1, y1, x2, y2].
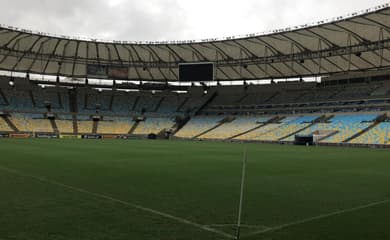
[0, 75, 390, 145]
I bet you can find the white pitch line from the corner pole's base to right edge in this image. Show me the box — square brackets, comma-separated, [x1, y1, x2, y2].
[243, 199, 390, 238]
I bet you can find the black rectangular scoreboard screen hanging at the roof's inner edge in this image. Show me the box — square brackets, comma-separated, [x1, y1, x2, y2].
[179, 63, 214, 82]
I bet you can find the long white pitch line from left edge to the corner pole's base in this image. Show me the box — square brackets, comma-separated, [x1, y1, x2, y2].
[0, 166, 235, 239]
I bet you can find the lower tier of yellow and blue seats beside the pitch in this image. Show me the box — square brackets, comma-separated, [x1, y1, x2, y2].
[0, 113, 390, 144]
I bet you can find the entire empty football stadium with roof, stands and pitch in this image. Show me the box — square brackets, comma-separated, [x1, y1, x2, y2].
[0, 1, 390, 240]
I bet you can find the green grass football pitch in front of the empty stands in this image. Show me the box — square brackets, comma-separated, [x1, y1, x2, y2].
[0, 139, 390, 240]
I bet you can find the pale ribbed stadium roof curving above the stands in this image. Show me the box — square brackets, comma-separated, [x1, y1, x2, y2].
[0, 4, 390, 81]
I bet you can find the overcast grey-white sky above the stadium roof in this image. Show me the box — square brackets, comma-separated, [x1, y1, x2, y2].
[0, 0, 387, 41]
